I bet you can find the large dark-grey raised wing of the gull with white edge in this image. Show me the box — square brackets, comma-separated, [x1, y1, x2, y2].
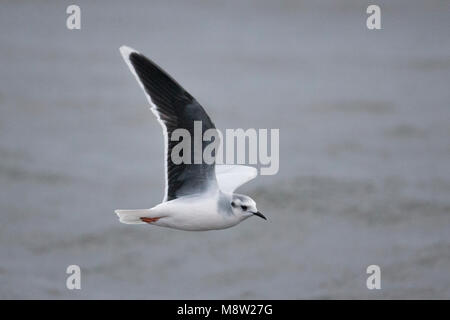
[120, 46, 217, 201]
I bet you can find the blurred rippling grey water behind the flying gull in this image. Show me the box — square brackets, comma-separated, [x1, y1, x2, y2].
[0, 0, 450, 299]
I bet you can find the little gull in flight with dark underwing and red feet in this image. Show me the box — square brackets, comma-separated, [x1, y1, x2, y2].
[115, 46, 266, 231]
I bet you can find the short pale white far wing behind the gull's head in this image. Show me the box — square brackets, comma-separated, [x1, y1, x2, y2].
[216, 164, 257, 193]
